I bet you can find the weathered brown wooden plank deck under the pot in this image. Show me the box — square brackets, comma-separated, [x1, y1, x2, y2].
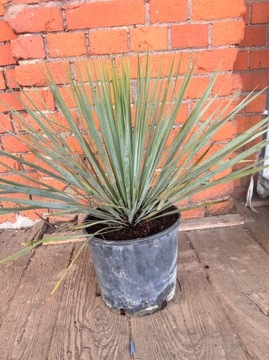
[0, 206, 269, 360]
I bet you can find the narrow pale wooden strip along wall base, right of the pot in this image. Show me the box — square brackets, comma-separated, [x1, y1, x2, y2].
[179, 214, 244, 231]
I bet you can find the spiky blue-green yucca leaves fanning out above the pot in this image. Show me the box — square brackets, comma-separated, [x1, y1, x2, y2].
[0, 57, 268, 270]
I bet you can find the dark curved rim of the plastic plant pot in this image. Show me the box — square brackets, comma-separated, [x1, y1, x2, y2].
[83, 206, 181, 246]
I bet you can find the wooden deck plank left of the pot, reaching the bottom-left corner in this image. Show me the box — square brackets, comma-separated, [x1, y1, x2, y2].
[0, 245, 72, 360]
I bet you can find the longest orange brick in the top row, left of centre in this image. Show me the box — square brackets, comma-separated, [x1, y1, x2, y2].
[66, 0, 146, 29]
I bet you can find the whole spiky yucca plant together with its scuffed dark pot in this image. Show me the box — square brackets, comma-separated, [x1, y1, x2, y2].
[0, 56, 268, 315]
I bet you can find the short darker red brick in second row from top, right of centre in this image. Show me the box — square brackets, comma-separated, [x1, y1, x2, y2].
[171, 24, 208, 48]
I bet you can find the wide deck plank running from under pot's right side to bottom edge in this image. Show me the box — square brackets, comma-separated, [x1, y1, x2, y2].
[131, 233, 248, 360]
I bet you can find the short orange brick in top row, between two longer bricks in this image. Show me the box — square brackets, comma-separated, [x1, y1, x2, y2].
[149, 0, 188, 23]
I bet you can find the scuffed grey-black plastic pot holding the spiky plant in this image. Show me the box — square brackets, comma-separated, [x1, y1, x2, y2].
[84, 211, 180, 316]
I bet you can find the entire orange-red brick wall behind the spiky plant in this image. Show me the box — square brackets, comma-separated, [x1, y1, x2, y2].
[0, 0, 269, 221]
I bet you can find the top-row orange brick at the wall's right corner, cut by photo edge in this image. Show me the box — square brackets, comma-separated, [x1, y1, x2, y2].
[191, 0, 246, 20]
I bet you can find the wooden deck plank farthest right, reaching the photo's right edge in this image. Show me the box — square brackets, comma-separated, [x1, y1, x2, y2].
[188, 227, 269, 360]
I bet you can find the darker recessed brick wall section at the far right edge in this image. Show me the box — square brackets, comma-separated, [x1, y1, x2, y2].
[234, 0, 269, 195]
